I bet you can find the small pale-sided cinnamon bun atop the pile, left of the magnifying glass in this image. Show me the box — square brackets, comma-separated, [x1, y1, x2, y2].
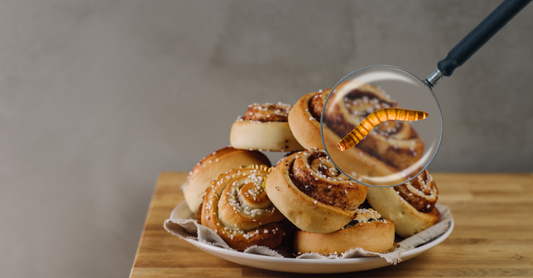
[230, 103, 303, 152]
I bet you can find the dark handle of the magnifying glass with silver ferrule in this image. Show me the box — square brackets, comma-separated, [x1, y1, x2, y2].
[427, 0, 531, 82]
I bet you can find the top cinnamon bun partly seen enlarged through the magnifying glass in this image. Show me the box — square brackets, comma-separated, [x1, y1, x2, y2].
[289, 82, 424, 185]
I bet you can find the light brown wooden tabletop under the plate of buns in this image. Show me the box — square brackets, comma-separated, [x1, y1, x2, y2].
[130, 172, 533, 277]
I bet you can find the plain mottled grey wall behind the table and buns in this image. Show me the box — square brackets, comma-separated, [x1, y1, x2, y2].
[0, 0, 533, 277]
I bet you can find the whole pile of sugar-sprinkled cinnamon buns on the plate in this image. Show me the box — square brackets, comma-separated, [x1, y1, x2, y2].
[185, 85, 439, 254]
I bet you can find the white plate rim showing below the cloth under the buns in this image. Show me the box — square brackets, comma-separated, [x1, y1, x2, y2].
[170, 202, 454, 273]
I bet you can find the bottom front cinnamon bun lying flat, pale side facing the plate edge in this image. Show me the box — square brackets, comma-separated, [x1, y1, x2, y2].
[294, 208, 394, 255]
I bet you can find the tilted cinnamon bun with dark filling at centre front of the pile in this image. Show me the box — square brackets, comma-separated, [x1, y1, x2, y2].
[266, 149, 367, 233]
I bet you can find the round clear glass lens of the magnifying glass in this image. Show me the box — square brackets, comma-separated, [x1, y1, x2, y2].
[320, 66, 443, 186]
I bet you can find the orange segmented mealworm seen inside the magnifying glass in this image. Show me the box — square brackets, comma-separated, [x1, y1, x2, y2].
[337, 108, 429, 151]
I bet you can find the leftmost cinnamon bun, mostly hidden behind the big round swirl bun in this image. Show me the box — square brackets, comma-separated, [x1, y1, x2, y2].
[185, 147, 270, 213]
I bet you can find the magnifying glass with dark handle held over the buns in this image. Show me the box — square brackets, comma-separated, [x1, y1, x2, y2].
[320, 0, 531, 186]
